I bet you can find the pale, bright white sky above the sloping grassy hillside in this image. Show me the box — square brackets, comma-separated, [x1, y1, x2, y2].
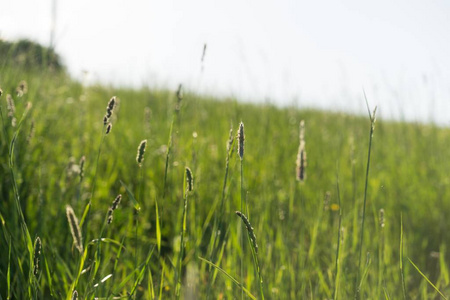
[0, 0, 450, 126]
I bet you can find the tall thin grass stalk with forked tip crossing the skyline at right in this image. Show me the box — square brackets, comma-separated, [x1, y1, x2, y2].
[355, 93, 377, 299]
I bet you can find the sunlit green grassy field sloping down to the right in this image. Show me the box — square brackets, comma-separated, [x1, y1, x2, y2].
[0, 41, 450, 299]
